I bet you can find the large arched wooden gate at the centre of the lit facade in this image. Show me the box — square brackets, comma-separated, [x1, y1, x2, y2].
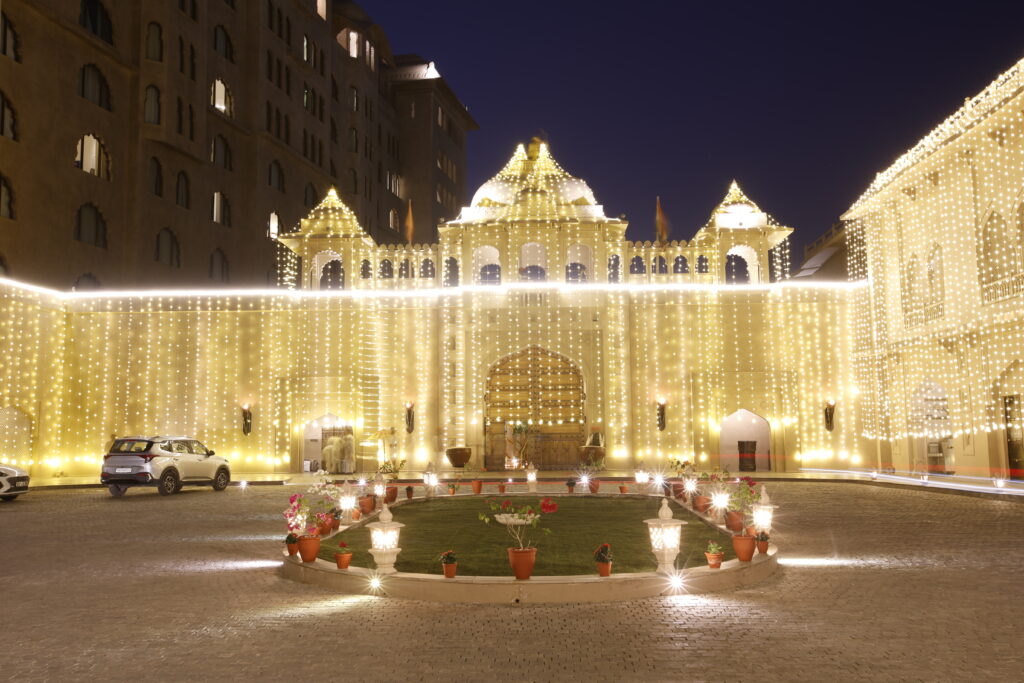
[483, 346, 586, 470]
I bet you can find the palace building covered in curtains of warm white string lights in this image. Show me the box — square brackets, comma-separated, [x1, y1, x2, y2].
[0, 58, 1024, 475]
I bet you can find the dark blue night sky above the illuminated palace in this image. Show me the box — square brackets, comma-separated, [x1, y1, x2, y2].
[372, 0, 1024, 259]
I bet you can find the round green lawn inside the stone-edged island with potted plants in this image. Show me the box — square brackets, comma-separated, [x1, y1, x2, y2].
[319, 496, 734, 577]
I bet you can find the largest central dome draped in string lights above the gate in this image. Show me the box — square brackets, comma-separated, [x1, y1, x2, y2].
[458, 137, 604, 221]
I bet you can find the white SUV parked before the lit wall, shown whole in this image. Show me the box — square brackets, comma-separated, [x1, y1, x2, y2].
[99, 436, 231, 498]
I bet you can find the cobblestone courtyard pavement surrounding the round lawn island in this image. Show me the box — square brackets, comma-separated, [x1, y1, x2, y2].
[0, 482, 1024, 681]
